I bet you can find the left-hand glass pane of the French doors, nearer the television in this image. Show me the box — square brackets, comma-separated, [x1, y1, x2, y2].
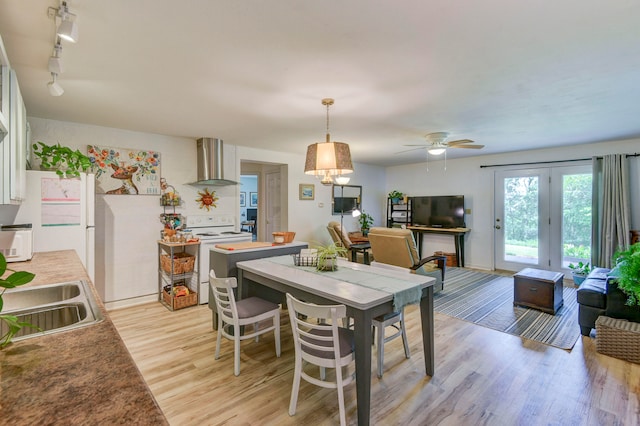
[503, 176, 539, 264]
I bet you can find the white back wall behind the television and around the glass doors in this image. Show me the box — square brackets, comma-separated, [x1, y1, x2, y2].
[385, 139, 640, 269]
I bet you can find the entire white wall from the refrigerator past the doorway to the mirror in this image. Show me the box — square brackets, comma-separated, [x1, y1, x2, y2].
[21, 117, 386, 301]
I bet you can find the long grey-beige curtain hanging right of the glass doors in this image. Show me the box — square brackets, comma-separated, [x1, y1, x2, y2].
[591, 154, 631, 268]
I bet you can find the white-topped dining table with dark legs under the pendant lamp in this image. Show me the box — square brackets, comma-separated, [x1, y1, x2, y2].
[236, 256, 435, 425]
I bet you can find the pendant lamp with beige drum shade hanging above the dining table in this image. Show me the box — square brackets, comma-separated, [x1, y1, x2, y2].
[304, 98, 353, 185]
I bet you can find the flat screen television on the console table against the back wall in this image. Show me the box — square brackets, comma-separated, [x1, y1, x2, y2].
[411, 195, 465, 228]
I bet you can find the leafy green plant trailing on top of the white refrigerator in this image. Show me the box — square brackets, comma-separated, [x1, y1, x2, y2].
[33, 141, 91, 177]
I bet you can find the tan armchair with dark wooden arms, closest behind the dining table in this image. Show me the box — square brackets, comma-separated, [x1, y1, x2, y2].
[369, 227, 447, 291]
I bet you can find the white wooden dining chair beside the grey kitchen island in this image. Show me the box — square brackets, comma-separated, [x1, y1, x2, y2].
[209, 270, 280, 376]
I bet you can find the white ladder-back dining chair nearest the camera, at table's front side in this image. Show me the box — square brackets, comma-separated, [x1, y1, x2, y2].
[287, 293, 355, 425]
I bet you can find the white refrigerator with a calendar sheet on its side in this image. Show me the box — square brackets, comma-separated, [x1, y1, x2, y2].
[14, 170, 95, 281]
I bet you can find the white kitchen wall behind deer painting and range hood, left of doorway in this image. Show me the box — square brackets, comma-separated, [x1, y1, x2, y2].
[29, 117, 239, 303]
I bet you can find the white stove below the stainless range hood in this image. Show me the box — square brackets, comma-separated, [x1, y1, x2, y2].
[185, 214, 253, 303]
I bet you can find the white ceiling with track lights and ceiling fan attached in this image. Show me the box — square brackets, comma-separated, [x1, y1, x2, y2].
[0, 0, 640, 165]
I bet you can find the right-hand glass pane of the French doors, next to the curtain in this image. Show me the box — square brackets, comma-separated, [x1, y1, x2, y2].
[562, 173, 592, 268]
